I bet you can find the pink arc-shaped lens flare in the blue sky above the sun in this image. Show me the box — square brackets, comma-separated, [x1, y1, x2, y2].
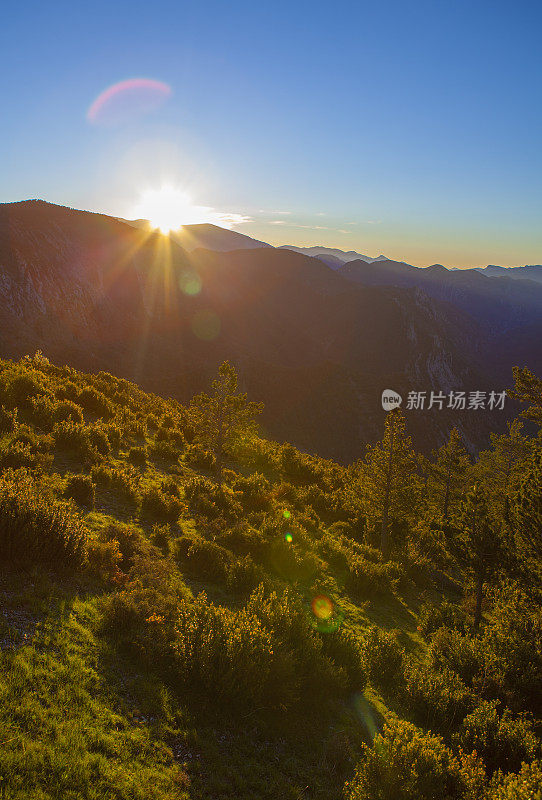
[87, 78, 171, 126]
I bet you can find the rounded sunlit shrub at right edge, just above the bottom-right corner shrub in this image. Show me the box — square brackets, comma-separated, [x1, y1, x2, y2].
[454, 701, 541, 773]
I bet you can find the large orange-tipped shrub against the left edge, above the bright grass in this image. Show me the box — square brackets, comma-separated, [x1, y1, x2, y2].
[0, 470, 86, 568]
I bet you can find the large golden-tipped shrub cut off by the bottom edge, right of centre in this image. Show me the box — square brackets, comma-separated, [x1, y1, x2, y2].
[345, 719, 485, 800]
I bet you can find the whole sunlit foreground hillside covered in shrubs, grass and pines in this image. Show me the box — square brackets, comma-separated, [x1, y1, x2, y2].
[0, 353, 542, 800]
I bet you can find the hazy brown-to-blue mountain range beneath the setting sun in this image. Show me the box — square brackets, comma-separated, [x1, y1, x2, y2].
[0, 201, 542, 461]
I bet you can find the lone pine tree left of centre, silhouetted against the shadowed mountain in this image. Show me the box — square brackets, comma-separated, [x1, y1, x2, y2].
[192, 361, 263, 486]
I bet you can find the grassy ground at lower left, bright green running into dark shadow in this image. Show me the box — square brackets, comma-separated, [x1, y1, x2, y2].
[0, 574, 374, 800]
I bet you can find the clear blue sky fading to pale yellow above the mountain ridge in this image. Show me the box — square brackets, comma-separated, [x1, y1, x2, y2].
[0, 0, 542, 266]
